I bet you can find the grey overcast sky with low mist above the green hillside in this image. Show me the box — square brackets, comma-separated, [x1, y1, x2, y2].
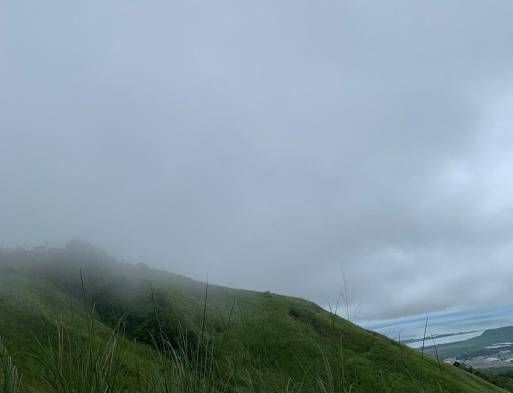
[0, 0, 513, 318]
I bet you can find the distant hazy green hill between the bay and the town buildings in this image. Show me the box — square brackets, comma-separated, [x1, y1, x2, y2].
[426, 326, 513, 359]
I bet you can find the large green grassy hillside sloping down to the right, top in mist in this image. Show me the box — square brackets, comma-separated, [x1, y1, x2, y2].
[0, 242, 504, 393]
